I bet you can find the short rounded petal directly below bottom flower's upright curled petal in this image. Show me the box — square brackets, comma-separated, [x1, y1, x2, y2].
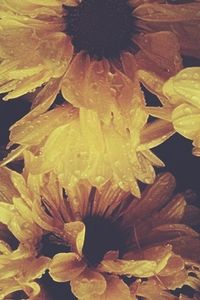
[49, 252, 86, 282]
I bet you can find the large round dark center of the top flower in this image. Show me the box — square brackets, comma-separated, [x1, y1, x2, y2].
[64, 0, 136, 59]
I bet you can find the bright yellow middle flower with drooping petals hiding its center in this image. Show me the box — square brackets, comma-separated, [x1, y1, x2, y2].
[3, 104, 174, 196]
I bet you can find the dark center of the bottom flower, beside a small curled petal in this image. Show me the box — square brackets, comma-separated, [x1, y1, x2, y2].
[83, 216, 124, 267]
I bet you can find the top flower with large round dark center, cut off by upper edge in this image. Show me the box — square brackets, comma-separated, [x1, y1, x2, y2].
[0, 0, 200, 118]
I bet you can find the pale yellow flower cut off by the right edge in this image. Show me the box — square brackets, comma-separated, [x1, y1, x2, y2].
[143, 67, 200, 156]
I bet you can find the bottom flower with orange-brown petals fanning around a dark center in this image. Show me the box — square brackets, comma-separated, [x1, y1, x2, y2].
[0, 165, 200, 300]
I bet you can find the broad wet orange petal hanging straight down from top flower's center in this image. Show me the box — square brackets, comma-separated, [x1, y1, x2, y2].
[62, 52, 136, 124]
